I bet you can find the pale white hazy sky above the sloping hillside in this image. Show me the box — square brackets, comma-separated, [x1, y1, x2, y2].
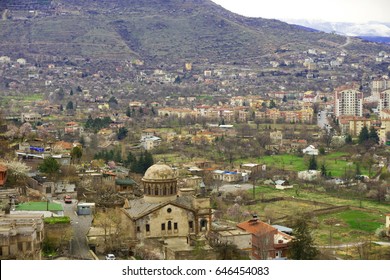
[212, 0, 390, 22]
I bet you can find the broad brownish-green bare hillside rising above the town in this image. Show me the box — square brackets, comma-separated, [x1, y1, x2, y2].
[0, 0, 390, 65]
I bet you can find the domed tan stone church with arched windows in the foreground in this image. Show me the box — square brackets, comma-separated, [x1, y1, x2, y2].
[121, 163, 211, 259]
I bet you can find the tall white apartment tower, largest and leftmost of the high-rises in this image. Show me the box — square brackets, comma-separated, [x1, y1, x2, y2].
[334, 89, 363, 117]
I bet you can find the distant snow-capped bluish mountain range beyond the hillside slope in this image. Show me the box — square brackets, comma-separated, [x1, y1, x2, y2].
[284, 19, 390, 43]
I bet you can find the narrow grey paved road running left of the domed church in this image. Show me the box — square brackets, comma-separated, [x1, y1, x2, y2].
[61, 199, 93, 260]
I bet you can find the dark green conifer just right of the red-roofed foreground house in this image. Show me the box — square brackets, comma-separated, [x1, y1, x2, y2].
[290, 217, 319, 260]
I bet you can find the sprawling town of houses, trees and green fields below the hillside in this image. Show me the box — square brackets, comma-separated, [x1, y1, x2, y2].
[0, 0, 390, 260]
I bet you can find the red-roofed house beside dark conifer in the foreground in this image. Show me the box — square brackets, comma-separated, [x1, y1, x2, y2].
[237, 216, 292, 260]
